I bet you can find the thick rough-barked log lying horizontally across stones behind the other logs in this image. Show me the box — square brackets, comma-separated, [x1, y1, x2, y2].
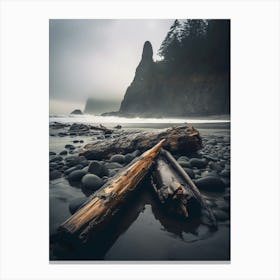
[80, 125, 201, 160]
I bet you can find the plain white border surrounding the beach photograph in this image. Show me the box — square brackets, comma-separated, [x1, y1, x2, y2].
[0, 0, 280, 280]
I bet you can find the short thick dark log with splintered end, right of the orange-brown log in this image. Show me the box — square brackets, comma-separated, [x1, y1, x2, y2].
[152, 153, 200, 218]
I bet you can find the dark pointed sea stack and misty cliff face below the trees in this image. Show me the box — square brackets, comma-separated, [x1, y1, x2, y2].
[119, 41, 230, 117]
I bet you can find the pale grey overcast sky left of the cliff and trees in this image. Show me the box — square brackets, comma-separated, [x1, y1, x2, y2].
[50, 19, 174, 114]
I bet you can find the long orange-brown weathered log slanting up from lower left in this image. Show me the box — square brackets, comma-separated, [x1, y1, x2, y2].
[59, 139, 164, 239]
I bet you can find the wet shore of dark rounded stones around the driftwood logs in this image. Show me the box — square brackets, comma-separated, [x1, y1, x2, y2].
[49, 123, 230, 260]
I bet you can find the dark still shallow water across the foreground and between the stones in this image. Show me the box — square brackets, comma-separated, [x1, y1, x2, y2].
[50, 121, 230, 261]
